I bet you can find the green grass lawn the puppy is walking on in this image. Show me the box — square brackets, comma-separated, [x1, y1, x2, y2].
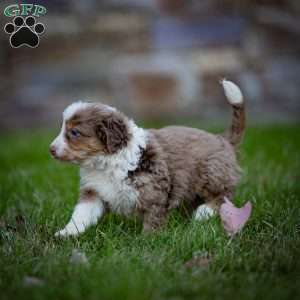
[0, 125, 300, 300]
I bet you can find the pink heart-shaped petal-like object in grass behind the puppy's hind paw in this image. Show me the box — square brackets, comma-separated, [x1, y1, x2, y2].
[220, 197, 252, 236]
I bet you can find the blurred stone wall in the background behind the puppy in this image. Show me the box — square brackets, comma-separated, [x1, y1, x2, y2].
[0, 0, 300, 130]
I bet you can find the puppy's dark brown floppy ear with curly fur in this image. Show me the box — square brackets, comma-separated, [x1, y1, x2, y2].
[96, 115, 129, 154]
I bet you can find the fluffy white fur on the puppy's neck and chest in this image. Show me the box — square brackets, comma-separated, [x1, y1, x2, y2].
[80, 120, 147, 215]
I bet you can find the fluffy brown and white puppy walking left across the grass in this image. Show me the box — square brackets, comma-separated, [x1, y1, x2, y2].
[50, 80, 245, 236]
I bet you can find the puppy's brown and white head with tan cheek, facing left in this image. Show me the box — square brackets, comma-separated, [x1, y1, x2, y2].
[50, 102, 131, 164]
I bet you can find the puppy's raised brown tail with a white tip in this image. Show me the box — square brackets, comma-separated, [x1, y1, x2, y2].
[221, 79, 246, 146]
